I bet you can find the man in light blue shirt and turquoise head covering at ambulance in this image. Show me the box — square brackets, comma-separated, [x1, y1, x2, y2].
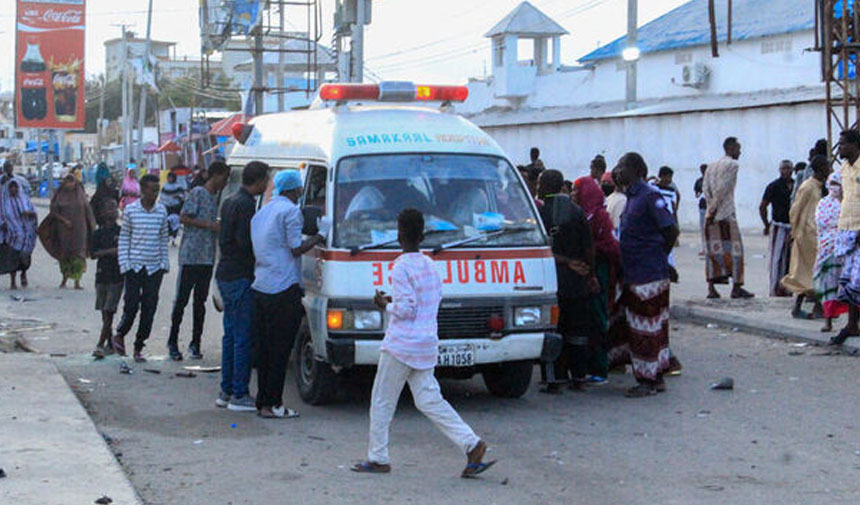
[251, 170, 324, 418]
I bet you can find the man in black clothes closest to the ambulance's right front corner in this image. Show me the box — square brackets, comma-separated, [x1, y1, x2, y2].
[538, 170, 600, 393]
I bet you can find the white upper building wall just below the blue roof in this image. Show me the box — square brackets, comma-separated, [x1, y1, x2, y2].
[458, 30, 821, 114]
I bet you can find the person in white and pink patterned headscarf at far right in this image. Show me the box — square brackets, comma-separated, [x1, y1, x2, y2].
[812, 170, 848, 332]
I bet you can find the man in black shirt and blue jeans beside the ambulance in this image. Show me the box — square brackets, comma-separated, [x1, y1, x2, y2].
[215, 161, 269, 412]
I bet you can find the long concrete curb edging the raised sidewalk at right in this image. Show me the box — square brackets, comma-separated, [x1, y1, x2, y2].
[669, 305, 860, 356]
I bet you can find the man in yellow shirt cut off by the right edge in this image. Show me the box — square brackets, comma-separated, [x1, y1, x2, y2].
[830, 130, 860, 345]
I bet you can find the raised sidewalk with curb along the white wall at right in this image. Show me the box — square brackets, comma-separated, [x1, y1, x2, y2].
[671, 233, 860, 354]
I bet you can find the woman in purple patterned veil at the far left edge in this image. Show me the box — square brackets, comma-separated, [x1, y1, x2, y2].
[0, 179, 36, 289]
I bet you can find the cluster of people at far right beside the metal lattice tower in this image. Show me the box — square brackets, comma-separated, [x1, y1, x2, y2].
[759, 130, 860, 345]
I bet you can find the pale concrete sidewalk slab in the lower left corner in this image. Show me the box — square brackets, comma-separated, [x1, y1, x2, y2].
[0, 353, 141, 505]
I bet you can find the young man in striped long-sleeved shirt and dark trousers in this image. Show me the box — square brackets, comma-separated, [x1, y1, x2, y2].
[113, 174, 170, 363]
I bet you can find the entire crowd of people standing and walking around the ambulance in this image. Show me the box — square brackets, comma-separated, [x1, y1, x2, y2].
[5, 130, 860, 476]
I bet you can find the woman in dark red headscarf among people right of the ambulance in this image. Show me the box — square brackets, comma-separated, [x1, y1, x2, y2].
[571, 177, 621, 382]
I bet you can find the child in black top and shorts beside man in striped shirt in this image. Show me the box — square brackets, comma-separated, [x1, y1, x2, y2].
[91, 200, 122, 359]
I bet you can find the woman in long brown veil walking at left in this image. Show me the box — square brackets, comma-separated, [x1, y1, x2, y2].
[39, 174, 96, 289]
